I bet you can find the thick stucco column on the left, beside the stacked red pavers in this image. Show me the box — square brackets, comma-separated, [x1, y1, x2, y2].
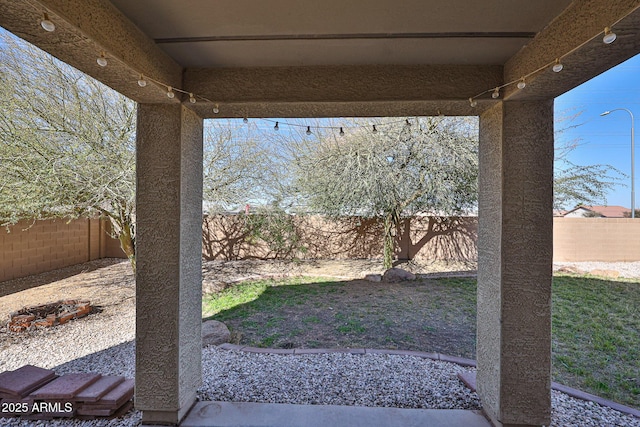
[135, 104, 202, 424]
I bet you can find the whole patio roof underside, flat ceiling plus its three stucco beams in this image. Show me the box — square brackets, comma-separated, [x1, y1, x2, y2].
[0, 0, 640, 117]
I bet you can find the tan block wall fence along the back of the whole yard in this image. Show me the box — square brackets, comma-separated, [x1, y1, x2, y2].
[0, 215, 640, 282]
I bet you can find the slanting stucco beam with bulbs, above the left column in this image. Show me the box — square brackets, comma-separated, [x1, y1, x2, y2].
[0, 0, 182, 103]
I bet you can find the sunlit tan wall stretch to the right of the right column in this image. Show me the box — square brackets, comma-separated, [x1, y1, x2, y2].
[553, 218, 640, 262]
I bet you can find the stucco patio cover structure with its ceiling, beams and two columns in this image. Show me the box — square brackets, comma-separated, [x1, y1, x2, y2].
[0, 0, 640, 426]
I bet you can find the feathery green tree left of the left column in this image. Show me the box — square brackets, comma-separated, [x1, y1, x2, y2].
[0, 31, 136, 268]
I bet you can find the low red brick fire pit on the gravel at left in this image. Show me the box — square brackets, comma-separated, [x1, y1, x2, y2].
[7, 299, 92, 332]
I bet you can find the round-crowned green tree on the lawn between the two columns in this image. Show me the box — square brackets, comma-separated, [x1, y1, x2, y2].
[292, 117, 478, 268]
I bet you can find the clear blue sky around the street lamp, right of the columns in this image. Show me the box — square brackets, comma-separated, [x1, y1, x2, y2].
[555, 51, 640, 209]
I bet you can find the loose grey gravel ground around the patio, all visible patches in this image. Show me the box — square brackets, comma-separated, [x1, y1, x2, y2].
[0, 263, 640, 427]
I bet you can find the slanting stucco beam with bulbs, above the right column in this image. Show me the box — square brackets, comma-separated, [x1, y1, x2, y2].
[504, 0, 640, 100]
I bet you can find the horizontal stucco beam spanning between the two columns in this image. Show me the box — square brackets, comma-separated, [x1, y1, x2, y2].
[184, 65, 503, 117]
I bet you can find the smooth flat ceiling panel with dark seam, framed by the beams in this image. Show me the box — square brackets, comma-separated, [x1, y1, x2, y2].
[113, 0, 570, 68]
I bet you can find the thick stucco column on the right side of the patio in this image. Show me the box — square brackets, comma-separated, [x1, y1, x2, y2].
[477, 100, 553, 426]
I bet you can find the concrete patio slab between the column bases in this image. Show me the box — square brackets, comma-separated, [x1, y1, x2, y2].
[180, 402, 491, 427]
